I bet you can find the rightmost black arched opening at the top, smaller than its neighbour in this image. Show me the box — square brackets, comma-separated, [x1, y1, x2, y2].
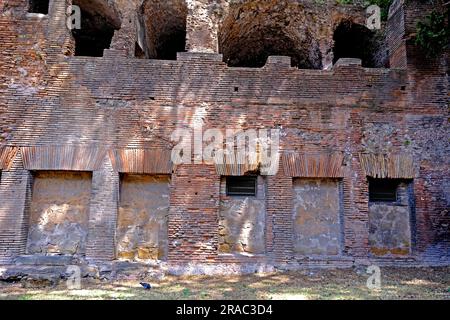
[333, 21, 383, 68]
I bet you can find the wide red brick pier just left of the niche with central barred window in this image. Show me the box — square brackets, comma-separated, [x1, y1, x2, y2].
[168, 165, 220, 263]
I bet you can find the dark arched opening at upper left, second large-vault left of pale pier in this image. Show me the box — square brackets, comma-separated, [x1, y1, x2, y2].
[72, 0, 121, 57]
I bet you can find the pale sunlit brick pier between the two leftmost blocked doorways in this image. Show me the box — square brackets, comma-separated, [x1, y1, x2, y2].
[86, 157, 120, 261]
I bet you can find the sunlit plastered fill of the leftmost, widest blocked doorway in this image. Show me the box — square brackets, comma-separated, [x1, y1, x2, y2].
[27, 172, 92, 255]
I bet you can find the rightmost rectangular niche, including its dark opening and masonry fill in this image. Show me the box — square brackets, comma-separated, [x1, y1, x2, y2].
[369, 179, 412, 256]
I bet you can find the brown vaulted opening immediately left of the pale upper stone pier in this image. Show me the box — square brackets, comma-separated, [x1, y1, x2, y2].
[138, 0, 188, 60]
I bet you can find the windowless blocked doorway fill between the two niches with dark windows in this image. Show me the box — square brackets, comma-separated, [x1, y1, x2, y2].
[293, 179, 340, 255]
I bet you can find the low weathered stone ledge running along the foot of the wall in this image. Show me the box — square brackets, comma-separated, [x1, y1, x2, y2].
[0, 256, 450, 287]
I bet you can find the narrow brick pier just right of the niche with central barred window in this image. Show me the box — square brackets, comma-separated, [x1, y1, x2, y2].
[266, 163, 294, 263]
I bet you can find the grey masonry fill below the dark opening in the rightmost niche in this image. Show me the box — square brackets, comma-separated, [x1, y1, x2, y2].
[369, 182, 411, 256]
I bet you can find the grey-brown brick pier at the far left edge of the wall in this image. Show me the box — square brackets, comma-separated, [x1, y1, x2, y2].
[0, 153, 32, 264]
